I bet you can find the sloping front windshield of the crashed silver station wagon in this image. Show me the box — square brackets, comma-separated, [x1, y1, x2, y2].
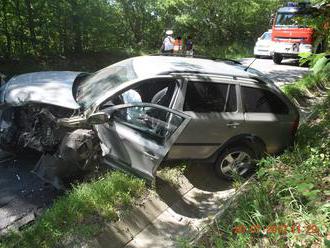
[76, 60, 137, 109]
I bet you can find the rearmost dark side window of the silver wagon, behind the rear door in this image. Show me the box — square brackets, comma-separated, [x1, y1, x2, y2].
[242, 86, 289, 114]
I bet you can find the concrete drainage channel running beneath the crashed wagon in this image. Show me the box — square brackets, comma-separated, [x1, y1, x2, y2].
[77, 164, 240, 248]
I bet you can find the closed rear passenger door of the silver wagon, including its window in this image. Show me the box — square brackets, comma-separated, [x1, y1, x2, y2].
[168, 77, 244, 159]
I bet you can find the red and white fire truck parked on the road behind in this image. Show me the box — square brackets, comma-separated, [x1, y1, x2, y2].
[271, 2, 322, 64]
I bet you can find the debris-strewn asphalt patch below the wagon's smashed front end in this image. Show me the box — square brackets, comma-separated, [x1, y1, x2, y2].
[0, 151, 60, 235]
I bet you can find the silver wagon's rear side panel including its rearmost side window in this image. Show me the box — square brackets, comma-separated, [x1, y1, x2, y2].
[241, 82, 299, 154]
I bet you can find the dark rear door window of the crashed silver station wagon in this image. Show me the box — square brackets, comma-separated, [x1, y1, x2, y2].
[183, 82, 237, 113]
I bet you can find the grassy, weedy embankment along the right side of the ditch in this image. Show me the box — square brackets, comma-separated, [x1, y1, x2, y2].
[188, 58, 330, 248]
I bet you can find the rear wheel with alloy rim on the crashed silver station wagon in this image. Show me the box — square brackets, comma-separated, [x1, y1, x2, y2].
[214, 146, 256, 180]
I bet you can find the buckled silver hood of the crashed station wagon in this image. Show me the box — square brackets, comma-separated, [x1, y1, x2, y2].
[1, 71, 81, 109]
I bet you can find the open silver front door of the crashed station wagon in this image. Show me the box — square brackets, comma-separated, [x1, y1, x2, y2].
[95, 103, 190, 181]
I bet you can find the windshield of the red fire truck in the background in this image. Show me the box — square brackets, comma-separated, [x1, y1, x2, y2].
[275, 13, 310, 27]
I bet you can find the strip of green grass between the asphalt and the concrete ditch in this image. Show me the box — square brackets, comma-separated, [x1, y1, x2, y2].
[0, 172, 146, 247]
